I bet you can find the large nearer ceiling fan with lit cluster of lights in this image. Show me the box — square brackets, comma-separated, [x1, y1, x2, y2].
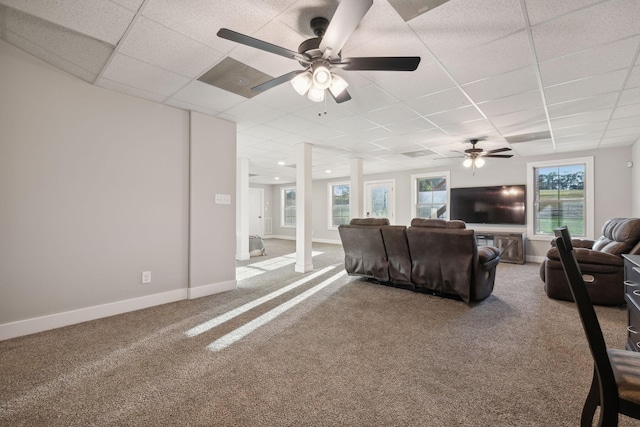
[217, 0, 420, 103]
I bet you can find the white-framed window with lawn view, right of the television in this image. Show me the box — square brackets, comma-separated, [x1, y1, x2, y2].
[527, 157, 593, 239]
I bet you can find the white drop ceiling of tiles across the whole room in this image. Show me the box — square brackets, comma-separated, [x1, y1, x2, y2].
[0, 0, 640, 184]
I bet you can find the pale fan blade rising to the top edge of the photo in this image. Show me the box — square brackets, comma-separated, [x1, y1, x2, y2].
[320, 0, 373, 59]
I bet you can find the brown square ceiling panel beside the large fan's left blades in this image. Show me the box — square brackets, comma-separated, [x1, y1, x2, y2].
[198, 58, 273, 98]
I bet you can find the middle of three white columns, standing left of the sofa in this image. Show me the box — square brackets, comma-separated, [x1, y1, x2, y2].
[294, 143, 313, 273]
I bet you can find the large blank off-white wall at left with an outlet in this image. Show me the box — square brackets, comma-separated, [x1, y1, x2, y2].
[0, 41, 235, 339]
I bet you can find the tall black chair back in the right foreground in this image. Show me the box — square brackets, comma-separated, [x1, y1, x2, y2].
[555, 226, 619, 426]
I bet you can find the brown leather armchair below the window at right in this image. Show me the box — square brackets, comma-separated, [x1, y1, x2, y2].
[540, 218, 640, 305]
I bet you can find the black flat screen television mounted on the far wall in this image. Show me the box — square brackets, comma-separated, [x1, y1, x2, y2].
[449, 185, 526, 225]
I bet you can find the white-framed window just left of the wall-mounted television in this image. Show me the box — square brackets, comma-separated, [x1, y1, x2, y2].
[411, 172, 449, 219]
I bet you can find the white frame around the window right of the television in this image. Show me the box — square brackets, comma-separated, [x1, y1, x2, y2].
[527, 156, 595, 241]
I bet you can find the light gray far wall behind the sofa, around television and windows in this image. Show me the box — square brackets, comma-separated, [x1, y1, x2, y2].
[273, 144, 640, 258]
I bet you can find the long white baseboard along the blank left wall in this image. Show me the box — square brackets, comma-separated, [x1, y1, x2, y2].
[0, 289, 188, 341]
